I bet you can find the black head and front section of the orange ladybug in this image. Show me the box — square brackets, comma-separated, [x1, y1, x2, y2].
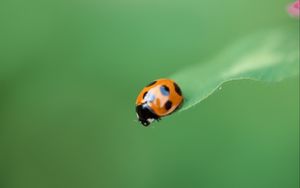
[135, 104, 159, 127]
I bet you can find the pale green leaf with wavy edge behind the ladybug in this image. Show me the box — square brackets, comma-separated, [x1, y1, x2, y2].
[170, 27, 299, 111]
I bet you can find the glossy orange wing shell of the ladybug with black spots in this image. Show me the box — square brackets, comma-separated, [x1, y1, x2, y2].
[136, 79, 183, 117]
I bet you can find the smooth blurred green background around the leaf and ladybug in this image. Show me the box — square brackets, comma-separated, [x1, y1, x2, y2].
[0, 0, 299, 188]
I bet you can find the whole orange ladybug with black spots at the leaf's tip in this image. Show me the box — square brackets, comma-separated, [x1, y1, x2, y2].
[136, 79, 183, 126]
